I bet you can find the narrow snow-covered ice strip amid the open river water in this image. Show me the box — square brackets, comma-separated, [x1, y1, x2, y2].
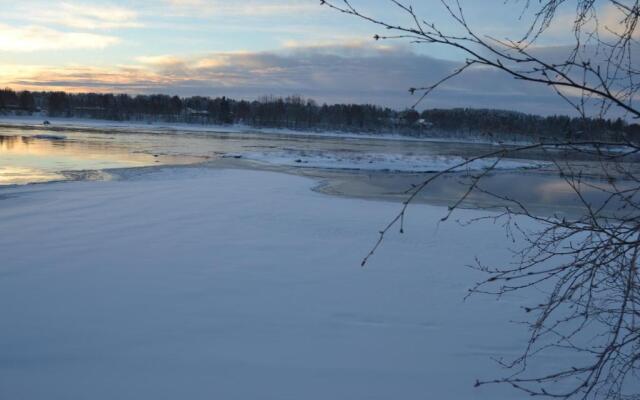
[232, 150, 549, 172]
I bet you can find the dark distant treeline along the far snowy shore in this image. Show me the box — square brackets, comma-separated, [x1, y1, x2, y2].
[0, 89, 640, 141]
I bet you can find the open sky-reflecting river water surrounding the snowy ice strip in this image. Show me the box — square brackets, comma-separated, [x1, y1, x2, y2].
[0, 128, 640, 217]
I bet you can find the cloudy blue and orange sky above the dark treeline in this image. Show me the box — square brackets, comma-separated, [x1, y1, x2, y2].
[0, 0, 628, 114]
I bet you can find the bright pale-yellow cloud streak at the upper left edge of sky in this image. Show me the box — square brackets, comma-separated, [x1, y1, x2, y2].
[0, 24, 119, 52]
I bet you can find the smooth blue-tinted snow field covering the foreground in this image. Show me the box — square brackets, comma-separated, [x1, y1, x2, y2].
[0, 168, 560, 400]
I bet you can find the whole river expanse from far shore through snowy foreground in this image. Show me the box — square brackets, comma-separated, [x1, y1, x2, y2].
[0, 117, 638, 400]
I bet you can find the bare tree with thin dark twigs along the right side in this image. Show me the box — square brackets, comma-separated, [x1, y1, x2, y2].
[320, 0, 640, 399]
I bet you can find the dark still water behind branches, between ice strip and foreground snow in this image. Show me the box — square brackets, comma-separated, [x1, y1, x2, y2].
[314, 171, 640, 219]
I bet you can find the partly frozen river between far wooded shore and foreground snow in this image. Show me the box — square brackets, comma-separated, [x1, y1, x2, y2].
[0, 121, 636, 216]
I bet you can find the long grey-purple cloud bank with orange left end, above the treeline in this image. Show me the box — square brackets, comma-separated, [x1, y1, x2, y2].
[0, 44, 592, 114]
